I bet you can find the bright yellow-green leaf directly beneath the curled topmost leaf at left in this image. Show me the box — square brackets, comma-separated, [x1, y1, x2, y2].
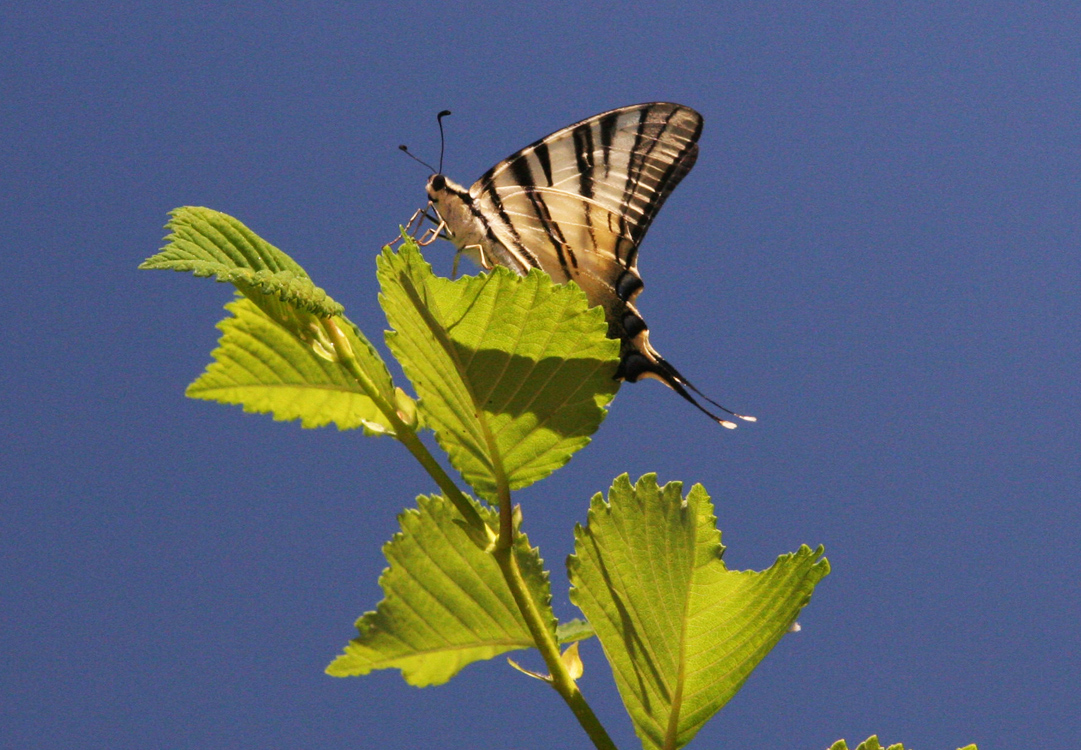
[187, 297, 395, 433]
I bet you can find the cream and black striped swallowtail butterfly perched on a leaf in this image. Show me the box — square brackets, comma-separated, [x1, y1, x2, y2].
[401, 102, 755, 428]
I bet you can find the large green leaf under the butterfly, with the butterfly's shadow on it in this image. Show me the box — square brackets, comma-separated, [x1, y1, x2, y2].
[378, 242, 619, 500]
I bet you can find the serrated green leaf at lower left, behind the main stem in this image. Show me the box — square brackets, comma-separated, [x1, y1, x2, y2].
[326, 496, 556, 687]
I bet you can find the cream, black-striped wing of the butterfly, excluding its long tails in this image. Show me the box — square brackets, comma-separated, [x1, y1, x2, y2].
[469, 103, 702, 335]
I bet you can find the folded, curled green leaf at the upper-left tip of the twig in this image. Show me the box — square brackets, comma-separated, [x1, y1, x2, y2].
[139, 205, 343, 317]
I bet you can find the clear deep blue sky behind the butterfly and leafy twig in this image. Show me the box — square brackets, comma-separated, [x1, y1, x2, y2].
[0, 2, 1081, 750]
